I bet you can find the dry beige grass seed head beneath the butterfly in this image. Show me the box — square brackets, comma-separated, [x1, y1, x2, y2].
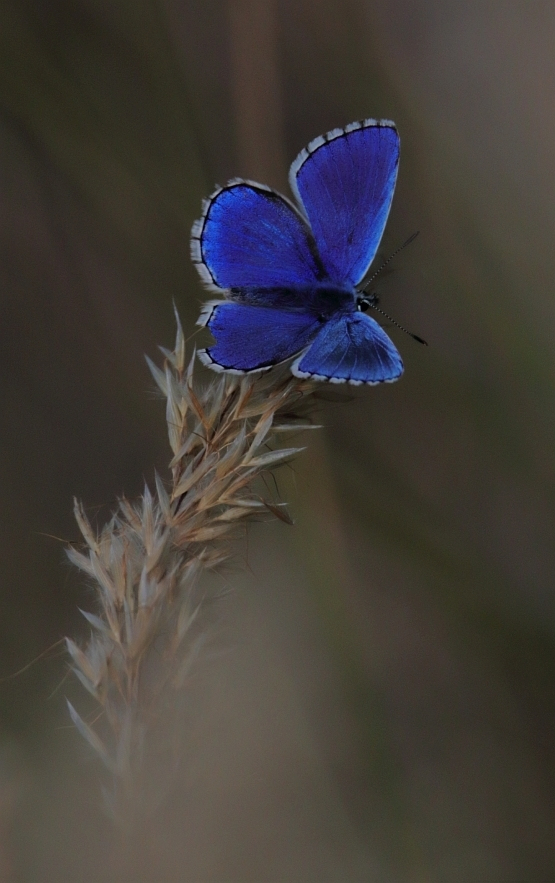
[67, 314, 315, 826]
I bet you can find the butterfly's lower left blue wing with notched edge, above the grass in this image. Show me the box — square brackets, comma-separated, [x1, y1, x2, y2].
[197, 301, 321, 374]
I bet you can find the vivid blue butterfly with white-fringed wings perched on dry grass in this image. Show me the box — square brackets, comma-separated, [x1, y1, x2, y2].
[191, 120, 403, 385]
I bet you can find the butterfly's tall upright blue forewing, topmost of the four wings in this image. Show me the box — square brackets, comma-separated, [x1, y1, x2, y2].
[289, 120, 399, 285]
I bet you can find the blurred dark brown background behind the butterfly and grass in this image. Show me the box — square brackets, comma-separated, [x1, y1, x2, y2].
[0, 0, 555, 883]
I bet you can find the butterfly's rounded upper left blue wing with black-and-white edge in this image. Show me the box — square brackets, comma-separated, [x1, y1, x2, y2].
[191, 180, 326, 290]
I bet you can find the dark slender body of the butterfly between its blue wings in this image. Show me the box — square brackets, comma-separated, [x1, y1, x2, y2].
[229, 282, 357, 322]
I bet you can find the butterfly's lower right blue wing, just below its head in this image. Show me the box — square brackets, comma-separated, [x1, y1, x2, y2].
[291, 312, 403, 386]
